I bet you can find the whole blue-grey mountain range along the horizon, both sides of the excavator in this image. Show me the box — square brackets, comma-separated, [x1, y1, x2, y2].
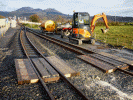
[0, 7, 133, 22]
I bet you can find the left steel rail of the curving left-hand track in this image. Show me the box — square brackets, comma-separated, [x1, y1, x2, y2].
[20, 26, 55, 100]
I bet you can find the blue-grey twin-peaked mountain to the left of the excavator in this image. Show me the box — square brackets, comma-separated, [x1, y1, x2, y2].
[0, 7, 67, 19]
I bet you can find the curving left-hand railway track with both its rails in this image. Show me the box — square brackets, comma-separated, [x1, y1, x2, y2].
[20, 27, 89, 100]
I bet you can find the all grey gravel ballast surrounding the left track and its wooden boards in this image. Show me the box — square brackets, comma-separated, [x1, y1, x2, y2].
[0, 28, 133, 100]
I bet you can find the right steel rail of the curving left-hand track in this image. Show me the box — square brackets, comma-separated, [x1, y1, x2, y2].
[26, 29, 90, 100]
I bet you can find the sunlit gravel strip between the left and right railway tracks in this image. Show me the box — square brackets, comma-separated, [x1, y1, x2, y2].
[27, 31, 133, 100]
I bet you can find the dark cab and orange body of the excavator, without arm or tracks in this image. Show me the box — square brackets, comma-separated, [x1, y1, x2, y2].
[72, 12, 91, 39]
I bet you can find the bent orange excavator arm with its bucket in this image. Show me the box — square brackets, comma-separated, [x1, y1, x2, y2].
[90, 13, 109, 33]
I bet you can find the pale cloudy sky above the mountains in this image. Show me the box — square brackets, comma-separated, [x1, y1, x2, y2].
[0, 0, 133, 17]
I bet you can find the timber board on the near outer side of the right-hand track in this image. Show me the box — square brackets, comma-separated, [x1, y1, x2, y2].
[77, 55, 117, 73]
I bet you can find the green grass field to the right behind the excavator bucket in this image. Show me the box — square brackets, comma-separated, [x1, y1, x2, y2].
[93, 25, 133, 49]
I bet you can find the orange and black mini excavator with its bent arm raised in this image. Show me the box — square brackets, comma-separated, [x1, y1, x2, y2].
[61, 12, 109, 45]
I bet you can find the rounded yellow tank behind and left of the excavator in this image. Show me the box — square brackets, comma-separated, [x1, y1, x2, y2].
[41, 20, 55, 32]
